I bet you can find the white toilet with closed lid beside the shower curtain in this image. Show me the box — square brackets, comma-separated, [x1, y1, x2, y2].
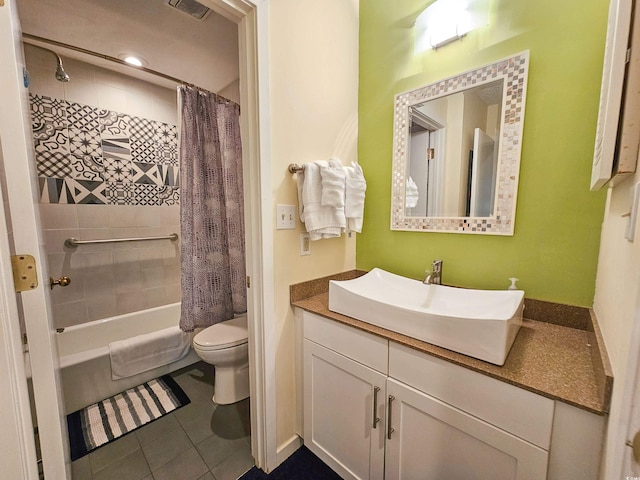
[193, 315, 249, 405]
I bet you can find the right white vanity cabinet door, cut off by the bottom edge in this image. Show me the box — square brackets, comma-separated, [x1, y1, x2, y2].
[385, 378, 548, 480]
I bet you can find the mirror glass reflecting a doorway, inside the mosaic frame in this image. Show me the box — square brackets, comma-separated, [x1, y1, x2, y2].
[405, 79, 504, 217]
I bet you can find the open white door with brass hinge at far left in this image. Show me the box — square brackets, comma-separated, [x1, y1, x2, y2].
[0, 0, 71, 480]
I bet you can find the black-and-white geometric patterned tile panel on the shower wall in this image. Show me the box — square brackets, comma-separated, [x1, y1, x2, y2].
[29, 94, 180, 205]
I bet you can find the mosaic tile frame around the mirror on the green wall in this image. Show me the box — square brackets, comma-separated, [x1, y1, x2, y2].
[391, 51, 529, 235]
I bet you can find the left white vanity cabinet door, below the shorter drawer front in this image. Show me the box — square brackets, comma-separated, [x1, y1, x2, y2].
[304, 339, 387, 479]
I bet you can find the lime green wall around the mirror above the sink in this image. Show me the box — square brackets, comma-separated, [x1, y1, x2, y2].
[356, 0, 608, 306]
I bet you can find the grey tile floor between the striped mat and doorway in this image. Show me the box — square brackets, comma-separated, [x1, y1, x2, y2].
[72, 362, 254, 480]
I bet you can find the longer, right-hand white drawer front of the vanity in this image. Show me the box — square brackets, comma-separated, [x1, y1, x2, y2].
[389, 342, 554, 450]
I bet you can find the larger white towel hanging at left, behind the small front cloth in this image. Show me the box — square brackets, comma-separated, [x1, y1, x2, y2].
[298, 161, 346, 240]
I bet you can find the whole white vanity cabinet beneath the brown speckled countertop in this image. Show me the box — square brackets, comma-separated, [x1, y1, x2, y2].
[296, 309, 606, 480]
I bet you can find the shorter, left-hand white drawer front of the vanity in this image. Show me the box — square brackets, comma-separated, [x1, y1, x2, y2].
[302, 311, 389, 375]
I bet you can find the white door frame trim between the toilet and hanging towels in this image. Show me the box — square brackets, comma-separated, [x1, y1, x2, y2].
[198, 0, 278, 473]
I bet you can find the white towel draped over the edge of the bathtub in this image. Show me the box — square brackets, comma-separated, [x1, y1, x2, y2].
[109, 326, 193, 380]
